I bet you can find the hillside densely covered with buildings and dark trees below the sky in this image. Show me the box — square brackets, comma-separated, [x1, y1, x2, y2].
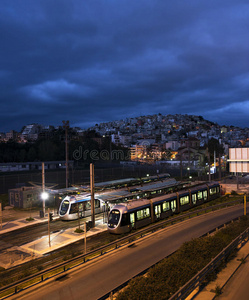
[0, 114, 249, 172]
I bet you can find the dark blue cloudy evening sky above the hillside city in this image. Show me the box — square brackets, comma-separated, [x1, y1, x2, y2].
[0, 0, 249, 132]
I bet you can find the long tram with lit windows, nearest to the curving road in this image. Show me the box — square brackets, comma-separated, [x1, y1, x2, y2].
[107, 182, 220, 234]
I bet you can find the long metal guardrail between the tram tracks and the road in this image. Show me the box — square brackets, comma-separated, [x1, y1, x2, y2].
[0, 199, 243, 299]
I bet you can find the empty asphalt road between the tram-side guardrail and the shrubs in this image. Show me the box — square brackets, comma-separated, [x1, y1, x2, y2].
[11, 205, 247, 300]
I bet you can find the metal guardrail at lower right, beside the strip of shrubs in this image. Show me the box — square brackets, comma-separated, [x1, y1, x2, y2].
[169, 228, 249, 300]
